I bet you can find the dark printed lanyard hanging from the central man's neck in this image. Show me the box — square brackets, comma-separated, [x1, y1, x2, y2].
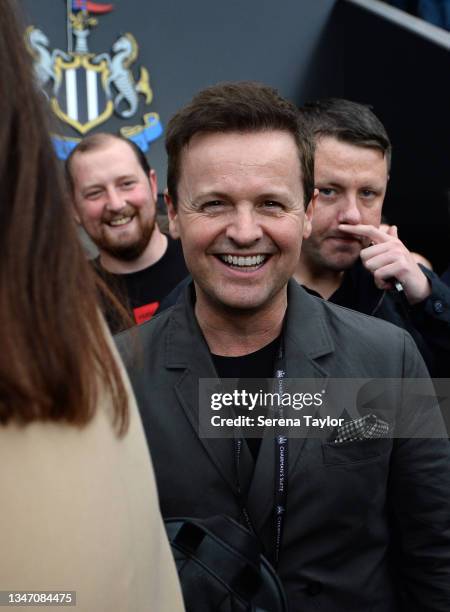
[234, 334, 289, 567]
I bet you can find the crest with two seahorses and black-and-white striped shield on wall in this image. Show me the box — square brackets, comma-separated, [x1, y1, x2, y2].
[25, 0, 162, 158]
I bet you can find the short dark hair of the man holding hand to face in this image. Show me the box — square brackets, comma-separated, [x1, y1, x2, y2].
[300, 98, 392, 170]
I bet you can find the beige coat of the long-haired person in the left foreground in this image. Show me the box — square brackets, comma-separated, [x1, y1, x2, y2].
[0, 346, 184, 612]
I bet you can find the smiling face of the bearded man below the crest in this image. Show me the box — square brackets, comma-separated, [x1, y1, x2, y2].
[70, 138, 157, 260]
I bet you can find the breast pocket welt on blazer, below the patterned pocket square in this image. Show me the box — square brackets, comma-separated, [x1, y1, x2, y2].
[322, 438, 392, 465]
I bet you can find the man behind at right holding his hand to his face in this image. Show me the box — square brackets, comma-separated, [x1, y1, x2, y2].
[294, 98, 450, 377]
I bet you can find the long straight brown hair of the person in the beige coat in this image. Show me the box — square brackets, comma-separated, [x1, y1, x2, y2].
[0, 0, 128, 433]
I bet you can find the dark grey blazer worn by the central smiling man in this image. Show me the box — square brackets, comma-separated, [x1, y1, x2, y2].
[117, 281, 450, 612]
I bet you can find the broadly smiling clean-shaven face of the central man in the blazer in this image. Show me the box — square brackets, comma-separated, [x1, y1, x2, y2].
[168, 130, 311, 311]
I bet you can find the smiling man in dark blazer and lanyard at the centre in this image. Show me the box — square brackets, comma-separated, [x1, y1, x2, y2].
[118, 83, 450, 612]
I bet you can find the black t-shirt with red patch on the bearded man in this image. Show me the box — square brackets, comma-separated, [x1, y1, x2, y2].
[92, 236, 188, 334]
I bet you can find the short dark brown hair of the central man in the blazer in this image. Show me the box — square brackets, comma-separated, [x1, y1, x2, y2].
[166, 81, 314, 208]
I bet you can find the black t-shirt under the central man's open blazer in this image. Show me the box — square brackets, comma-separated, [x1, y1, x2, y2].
[211, 337, 280, 461]
